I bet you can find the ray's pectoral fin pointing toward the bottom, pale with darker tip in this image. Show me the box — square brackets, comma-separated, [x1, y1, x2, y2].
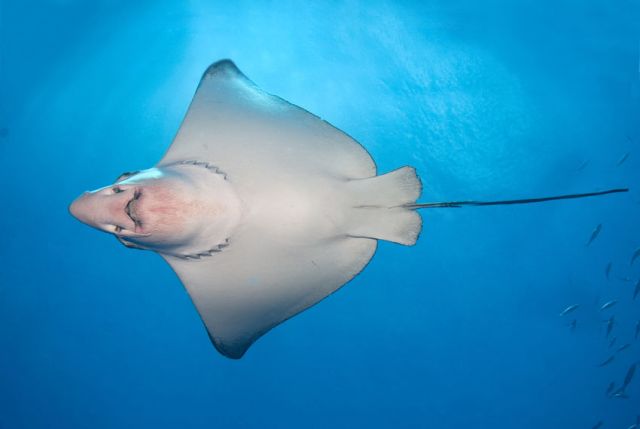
[163, 229, 376, 359]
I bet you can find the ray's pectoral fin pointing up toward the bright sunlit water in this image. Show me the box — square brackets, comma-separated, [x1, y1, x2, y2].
[158, 60, 376, 181]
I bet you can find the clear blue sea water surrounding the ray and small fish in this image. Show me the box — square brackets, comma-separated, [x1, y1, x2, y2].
[0, 0, 640, 429]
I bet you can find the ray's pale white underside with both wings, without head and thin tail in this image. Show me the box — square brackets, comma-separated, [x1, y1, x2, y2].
[157, 61, 421, 358]
